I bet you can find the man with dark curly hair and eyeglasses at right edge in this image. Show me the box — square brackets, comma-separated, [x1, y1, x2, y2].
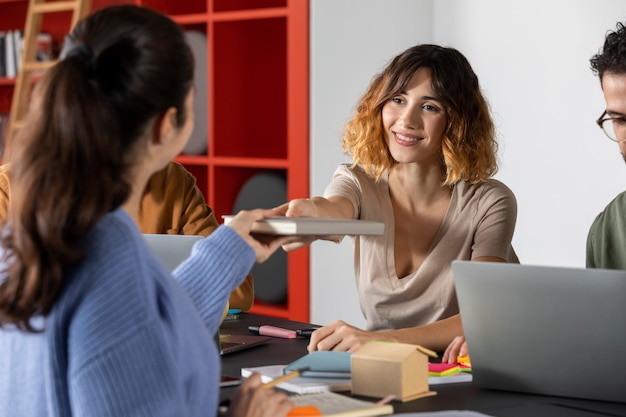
[587, 22, 626, 270]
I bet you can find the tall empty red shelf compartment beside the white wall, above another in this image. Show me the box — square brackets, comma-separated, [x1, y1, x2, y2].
[209, 18, 288, 159]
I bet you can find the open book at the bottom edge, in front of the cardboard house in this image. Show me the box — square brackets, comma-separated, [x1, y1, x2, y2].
[289, 392, 393, 417]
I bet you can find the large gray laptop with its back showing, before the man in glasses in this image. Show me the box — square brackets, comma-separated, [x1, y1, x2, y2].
[452, 261, 626, 402]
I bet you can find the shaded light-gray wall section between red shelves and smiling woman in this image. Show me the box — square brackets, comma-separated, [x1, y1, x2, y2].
[310, 0, 433, 326]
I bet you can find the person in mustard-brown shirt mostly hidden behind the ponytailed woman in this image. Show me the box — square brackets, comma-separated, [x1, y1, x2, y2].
[0, 161, 254, 311]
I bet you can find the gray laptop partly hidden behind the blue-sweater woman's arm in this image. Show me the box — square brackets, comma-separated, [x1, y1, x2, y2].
[143, 234, 270, 355]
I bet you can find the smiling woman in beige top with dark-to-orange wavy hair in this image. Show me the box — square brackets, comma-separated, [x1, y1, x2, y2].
[275, 44, 518, 358]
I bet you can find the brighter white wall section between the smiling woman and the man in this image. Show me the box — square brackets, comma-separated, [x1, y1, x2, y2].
[434, 0, 626, 267]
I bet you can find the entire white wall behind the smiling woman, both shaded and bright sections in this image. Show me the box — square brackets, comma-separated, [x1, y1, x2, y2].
[310, 0, 626, 326]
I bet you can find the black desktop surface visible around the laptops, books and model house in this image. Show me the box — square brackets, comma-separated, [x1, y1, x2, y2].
[220, 314, 626, 417]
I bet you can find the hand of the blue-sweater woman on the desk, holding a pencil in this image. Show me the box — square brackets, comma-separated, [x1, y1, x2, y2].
[226, 373, 295, 417]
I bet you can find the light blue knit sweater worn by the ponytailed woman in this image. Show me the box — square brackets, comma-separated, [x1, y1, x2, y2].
[0, 209, 255, 417]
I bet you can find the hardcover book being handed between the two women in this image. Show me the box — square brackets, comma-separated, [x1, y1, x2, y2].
[222, 215, 385, 236]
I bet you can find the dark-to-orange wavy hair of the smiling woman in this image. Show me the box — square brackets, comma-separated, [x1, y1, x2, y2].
[343, 44, 498, 185]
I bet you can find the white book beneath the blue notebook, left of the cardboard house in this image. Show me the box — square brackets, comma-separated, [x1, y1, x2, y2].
[241, 365, 352, 394]
